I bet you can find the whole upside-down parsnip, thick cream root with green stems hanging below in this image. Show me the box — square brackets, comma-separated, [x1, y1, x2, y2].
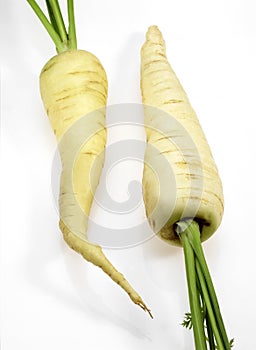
[141, 26, 233, 350]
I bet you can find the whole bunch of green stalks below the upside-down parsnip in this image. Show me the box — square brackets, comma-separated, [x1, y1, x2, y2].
[176, 220, 233, 350]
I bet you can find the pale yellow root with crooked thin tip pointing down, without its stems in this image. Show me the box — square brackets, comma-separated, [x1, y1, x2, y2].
[40, 50, 152, 312]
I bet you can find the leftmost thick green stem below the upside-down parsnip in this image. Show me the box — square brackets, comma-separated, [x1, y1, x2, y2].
[181, 231, 207, 350]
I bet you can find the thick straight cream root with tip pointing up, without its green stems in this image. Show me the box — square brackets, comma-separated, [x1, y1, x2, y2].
[141, 26, 223, 245]
